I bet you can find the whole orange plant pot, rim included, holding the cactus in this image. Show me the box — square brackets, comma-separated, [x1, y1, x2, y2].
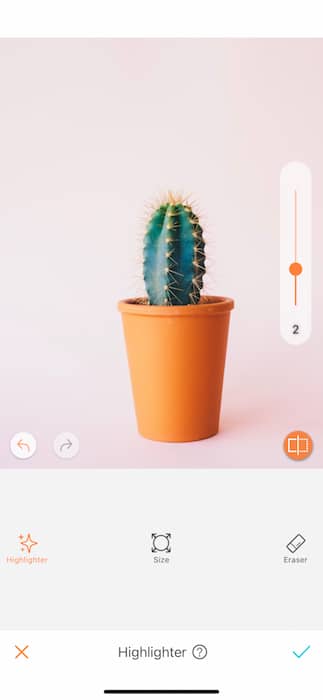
[118, 297, 234, 442]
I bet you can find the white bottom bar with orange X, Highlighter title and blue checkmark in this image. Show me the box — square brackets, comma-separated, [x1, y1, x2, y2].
[0, 630, 323, 700]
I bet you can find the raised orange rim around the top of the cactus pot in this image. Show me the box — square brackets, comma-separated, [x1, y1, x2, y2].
[118, 295, 234, 316]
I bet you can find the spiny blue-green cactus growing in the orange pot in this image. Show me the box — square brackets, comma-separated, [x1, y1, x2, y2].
[144, 194, 205, 306]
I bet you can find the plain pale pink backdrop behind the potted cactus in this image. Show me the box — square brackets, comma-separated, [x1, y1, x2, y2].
[0, 39, 323, 468]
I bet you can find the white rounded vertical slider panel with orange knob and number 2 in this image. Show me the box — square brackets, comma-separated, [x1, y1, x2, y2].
[280, 162, 312, 345]
